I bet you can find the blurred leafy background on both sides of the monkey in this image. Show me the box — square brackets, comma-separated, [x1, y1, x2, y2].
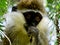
[0, 0, 60, 45]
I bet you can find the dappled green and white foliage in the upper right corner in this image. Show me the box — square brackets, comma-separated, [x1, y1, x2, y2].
[47, 0, 60, 19]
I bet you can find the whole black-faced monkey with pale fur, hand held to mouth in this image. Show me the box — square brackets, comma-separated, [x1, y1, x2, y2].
[3, 0, 49, 45]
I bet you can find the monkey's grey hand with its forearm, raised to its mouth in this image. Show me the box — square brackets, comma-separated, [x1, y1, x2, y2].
[28, 26, 40, 45]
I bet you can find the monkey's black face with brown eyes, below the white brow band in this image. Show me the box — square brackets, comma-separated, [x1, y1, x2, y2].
[23, 11, 42, 26]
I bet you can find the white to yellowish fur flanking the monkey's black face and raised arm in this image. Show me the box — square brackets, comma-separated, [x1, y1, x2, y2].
[3, 12, 56, 45]
